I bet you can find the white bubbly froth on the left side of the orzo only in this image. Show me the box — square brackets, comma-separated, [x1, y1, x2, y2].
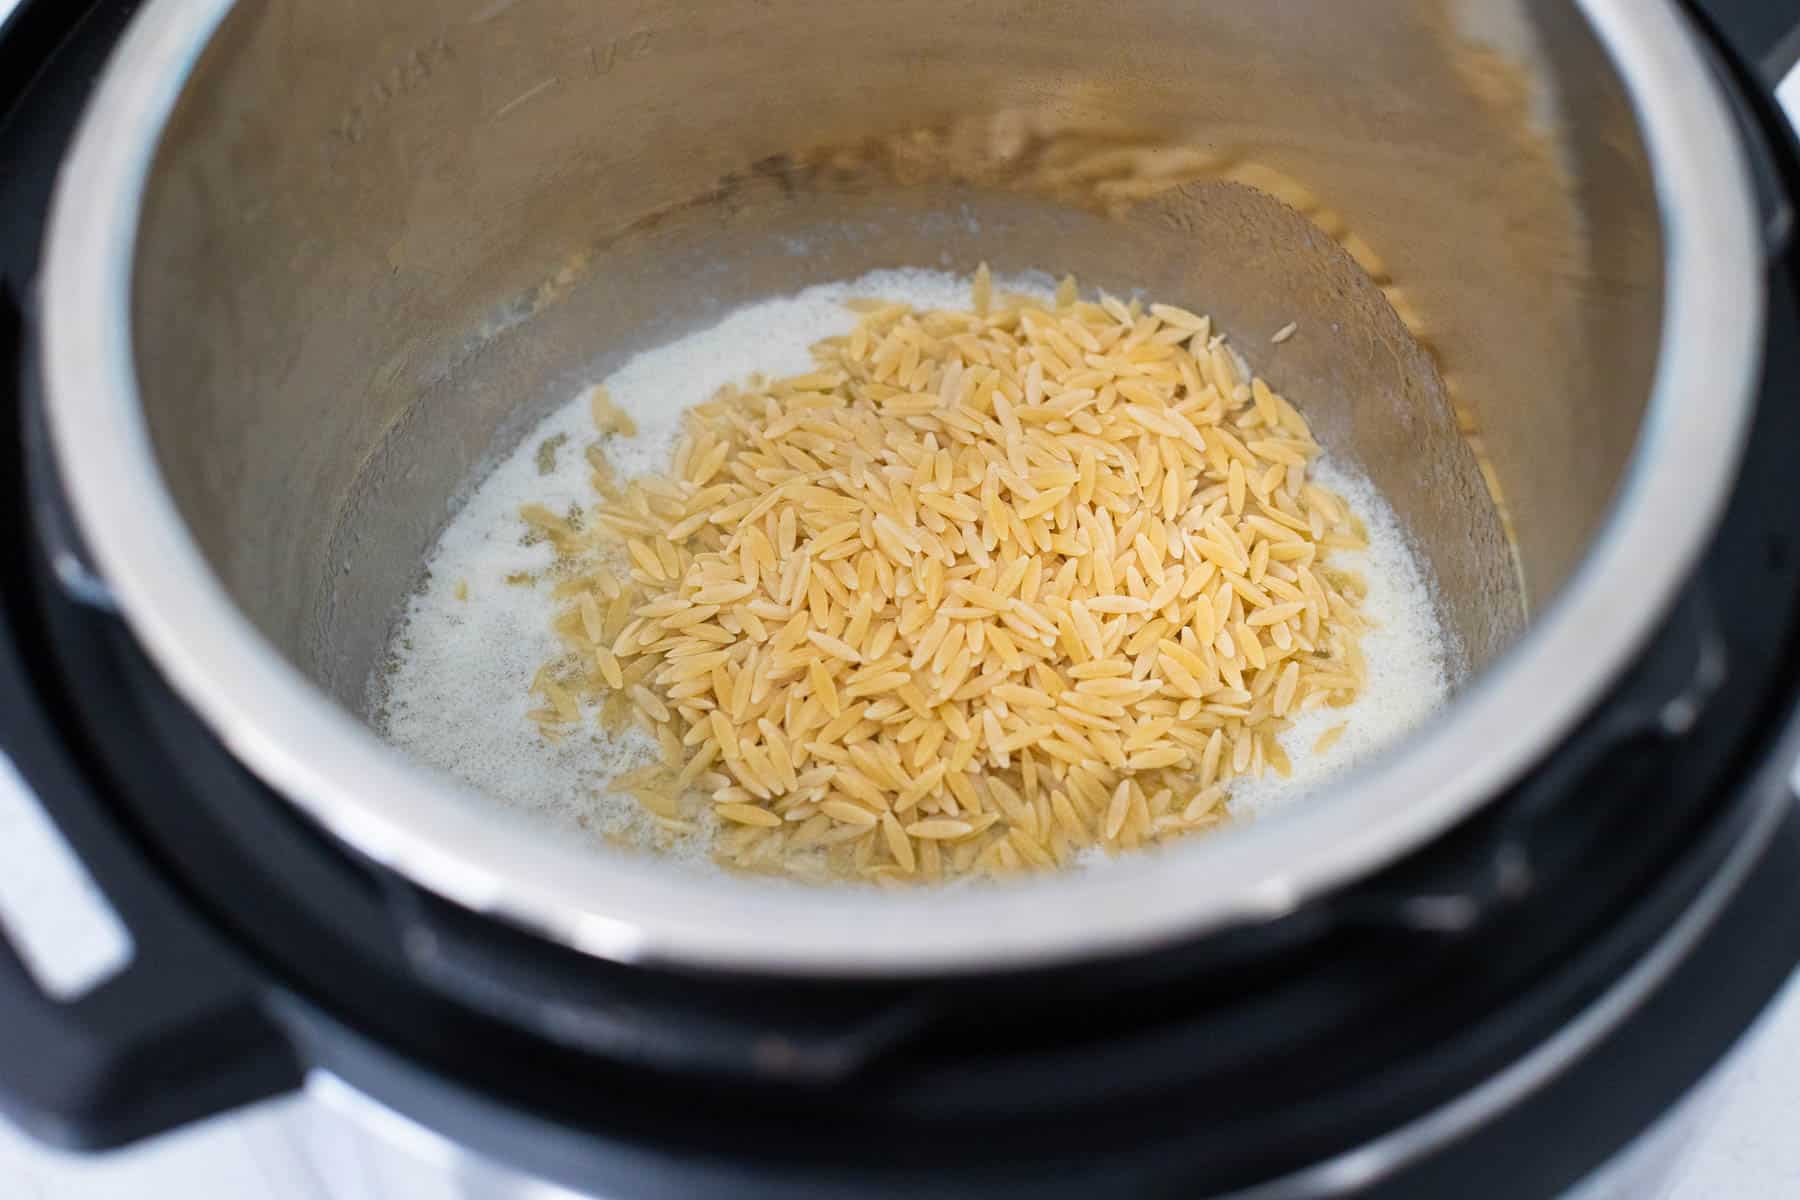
[374, 270, 1008, 865]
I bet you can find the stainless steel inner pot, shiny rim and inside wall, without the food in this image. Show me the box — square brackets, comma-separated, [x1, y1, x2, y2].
[43, 0, 1762, 972]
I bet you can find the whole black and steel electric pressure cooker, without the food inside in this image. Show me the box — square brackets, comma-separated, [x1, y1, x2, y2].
[0, 0, 1800, 1198]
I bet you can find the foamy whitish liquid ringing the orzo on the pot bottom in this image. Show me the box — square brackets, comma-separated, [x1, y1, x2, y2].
[371, 272, 1454, 878]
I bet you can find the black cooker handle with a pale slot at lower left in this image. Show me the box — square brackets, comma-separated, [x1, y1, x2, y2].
[0, 290, 301, 1150]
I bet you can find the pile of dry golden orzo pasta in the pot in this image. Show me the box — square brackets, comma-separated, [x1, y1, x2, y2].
[524, 266, 1366, 882]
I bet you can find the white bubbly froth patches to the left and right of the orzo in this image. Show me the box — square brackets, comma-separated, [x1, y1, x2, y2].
[374, 270, 1449, 865]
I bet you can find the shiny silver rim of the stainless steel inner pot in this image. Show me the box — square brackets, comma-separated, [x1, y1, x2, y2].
[40, 0, 1764, 975]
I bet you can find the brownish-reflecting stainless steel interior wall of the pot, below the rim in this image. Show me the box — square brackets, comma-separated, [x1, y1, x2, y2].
[133, 0, 1661, 723]
